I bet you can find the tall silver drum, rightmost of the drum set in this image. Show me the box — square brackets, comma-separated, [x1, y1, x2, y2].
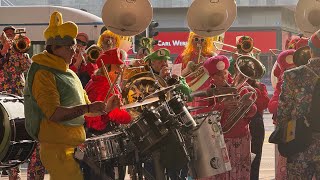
[190, 112, 231, 179]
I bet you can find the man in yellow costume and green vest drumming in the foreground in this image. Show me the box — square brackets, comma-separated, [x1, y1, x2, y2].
[24, 12, 120, 180]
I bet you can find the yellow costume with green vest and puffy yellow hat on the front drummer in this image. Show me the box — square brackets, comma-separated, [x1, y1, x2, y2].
[25, 12, 89, 180]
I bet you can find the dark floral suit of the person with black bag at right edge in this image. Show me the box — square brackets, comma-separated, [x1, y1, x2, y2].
[277, 31, 320, 179]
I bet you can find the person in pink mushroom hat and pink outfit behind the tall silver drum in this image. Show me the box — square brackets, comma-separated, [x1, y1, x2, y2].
[203, 55, 257, 179]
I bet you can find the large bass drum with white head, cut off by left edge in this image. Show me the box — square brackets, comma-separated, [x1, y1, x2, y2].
[0, 93, 36, 169]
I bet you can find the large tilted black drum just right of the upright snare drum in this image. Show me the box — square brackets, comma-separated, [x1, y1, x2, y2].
[125, 106, 169, 153]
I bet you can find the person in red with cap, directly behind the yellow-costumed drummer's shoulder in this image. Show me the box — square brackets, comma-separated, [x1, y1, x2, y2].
[69, 32, 98, 87]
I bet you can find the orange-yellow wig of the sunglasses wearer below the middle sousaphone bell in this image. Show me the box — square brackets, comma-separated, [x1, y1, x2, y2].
[182, 31, 216, 64]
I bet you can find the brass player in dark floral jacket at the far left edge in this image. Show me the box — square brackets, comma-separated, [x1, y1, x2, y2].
[0, 26, 45, 180]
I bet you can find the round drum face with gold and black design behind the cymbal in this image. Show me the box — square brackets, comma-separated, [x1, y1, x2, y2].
[122, 72, 170, 119]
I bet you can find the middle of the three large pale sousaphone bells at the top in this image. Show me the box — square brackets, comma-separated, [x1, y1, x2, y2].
[187, 0, 237, 37]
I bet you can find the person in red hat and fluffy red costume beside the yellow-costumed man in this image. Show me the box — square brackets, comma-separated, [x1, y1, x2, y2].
[85, 48, 131, 179]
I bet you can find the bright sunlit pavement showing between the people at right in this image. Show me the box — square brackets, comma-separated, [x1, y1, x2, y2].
[0, 113, 275, 180]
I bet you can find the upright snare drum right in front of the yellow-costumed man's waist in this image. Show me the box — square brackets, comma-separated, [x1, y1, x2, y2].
[84, 132, 128, 161]
